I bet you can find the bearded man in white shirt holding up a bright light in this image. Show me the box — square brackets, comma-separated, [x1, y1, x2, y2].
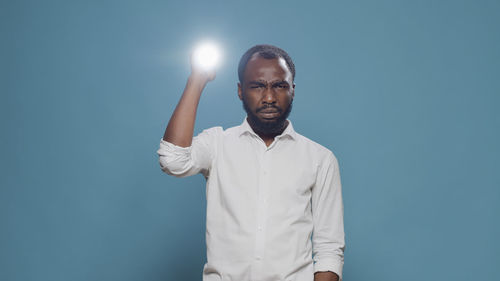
[158, 45, 344, 281]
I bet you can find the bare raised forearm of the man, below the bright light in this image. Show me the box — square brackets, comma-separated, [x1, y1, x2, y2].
[163, 74, 208, 147]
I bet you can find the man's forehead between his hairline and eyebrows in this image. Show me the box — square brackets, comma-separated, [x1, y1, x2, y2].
[243, 53, 292, 81]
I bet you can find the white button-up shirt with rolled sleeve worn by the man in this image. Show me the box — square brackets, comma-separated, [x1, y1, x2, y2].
[157, 118, 345, 281]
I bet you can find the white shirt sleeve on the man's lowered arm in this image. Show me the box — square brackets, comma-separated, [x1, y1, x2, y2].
[311, 151, 345, 280]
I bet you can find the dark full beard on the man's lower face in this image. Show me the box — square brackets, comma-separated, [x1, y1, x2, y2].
[243, 99, 293, 135]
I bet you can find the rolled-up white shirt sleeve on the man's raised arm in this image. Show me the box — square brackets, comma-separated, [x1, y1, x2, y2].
[157, 127, 222, 178]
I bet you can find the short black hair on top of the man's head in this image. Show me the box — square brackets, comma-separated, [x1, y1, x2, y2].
[238, 44, 295, 83]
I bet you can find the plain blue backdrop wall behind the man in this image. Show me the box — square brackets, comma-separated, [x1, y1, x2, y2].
[0, 1, 500, 281]
